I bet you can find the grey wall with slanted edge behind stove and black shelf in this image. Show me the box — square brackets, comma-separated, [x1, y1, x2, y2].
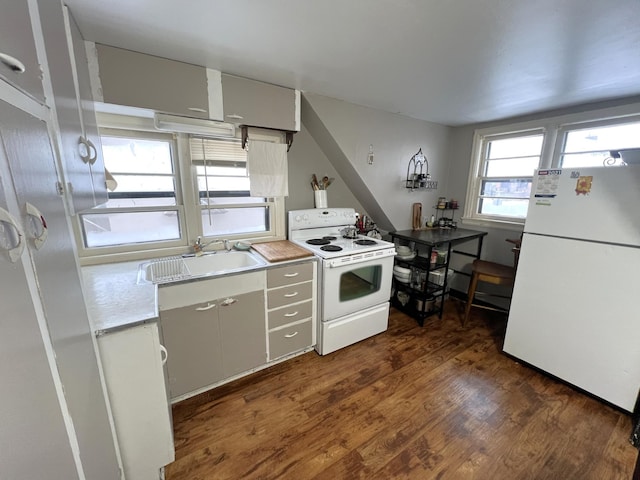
[302, 93, 451, 231]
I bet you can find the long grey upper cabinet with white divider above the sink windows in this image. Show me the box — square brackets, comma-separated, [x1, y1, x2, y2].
[93, 44, 300, 132]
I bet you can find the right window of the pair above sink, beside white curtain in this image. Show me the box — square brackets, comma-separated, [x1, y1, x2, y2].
[190, 137, 275, 237]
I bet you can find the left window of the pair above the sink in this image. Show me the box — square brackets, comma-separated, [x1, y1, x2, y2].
[79, 130, 183, 251]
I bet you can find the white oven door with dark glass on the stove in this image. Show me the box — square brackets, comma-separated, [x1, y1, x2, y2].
[321, 250, 395, 322]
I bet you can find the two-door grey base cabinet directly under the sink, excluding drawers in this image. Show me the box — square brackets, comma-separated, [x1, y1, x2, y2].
[158, 270, 267, 401]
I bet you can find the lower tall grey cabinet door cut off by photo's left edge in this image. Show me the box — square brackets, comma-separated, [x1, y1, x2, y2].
[0, 107, 77, 479]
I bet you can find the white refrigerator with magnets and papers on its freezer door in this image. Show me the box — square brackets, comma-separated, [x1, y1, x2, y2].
[504, 166, 640, 411]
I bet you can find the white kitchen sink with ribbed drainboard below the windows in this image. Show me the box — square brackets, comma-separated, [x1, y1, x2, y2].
[138, 252, 267, 284]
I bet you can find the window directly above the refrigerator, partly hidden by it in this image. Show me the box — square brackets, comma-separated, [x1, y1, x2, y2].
[560, 121, 640, 168]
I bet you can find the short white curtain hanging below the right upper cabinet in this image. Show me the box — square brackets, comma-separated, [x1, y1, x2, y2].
[247, 140, 289, 197]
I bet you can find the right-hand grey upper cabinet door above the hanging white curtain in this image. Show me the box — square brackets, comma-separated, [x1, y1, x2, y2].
[222, 74, 300, 131]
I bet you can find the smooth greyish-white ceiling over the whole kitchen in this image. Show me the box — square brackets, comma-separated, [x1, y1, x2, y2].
[66, 0, 640, 126]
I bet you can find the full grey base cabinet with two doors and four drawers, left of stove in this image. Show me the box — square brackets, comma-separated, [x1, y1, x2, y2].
[158, 266, 317, 402]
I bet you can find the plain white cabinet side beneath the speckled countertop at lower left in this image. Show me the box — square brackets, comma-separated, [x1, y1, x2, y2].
[98, 323, 175, 480]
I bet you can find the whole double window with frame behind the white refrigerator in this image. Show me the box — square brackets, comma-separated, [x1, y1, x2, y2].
[463, 104, 640, 228]
